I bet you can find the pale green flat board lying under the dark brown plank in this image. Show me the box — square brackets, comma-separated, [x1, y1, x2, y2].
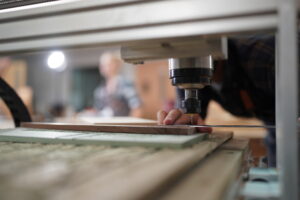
[0, 128, 207, 148]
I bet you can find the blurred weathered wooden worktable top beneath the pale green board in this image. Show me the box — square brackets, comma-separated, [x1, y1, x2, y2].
[0, 133, 232, 200]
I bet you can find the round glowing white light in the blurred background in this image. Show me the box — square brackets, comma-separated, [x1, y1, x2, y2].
[47, 51, 66, 71]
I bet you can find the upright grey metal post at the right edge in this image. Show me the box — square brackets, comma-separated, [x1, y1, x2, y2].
[276, 0, 300, 200]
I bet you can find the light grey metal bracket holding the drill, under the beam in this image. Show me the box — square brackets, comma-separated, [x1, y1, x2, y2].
[121, 37, 227, 63]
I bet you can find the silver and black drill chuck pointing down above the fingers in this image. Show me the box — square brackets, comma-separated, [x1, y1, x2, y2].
[169, 56, 213, 114]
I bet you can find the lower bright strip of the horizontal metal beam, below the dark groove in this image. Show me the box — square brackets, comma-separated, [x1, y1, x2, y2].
[0, 15, 277, 54]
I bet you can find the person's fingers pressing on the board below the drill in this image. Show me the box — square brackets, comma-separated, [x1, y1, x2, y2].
[157, 109, 212, 133]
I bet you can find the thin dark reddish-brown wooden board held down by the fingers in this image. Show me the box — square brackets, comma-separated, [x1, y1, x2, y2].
[21, 122, 197, 135]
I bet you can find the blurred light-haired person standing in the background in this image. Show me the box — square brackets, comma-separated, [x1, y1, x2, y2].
[94, 52, 142, 117]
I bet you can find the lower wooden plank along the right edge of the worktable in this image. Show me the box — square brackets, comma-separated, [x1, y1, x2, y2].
[158, 140, 248, 200]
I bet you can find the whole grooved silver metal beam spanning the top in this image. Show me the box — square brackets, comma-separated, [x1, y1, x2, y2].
[0, 0, 277, 54]
